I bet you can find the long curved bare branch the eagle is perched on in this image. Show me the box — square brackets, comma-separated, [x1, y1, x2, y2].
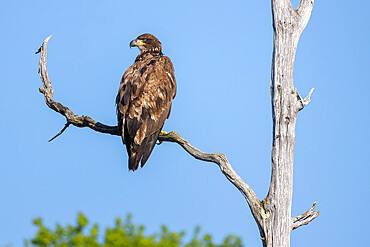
[36, 36, 266, 229]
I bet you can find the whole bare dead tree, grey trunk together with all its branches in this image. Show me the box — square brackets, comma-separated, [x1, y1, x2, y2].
[37, 0, 320, 247]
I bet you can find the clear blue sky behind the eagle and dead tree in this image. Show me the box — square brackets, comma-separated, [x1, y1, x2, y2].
[0, 0, 370, 246]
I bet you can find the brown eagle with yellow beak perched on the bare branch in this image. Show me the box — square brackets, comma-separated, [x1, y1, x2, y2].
[116, 33, 176, 171]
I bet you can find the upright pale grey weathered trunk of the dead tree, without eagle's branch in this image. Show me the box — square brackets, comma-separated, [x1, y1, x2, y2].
[263, 0, 318, 247]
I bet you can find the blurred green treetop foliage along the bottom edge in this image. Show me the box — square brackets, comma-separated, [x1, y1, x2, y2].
[25, 213, 242, 247]
